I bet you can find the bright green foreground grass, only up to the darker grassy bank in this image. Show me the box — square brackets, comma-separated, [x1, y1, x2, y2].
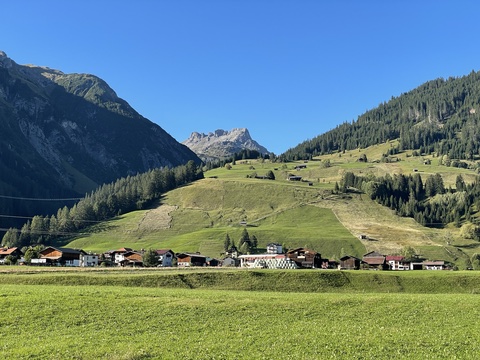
[0, 285, 480, 359]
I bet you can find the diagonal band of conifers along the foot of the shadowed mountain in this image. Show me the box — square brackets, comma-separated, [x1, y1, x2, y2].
[2, 160, 203, 247]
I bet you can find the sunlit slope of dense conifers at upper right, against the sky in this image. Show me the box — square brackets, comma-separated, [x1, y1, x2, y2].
[282, 71, 480, 160]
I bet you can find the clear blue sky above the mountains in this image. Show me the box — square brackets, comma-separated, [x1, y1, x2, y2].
[0, 0, 480, 154]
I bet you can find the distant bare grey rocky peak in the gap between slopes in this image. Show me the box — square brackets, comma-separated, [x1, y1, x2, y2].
[182, 128, 269, 159]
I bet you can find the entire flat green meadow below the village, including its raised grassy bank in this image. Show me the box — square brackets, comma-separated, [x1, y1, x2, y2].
[0, 269, 480, 359]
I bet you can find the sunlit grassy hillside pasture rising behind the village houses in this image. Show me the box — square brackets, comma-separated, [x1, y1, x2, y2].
[65, 141, 480, 268]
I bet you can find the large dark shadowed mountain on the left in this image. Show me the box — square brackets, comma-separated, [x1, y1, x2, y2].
[0, 51, 200, 222]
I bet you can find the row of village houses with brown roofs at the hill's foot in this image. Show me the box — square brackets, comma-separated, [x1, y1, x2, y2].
[0, 243, 450, 270]
